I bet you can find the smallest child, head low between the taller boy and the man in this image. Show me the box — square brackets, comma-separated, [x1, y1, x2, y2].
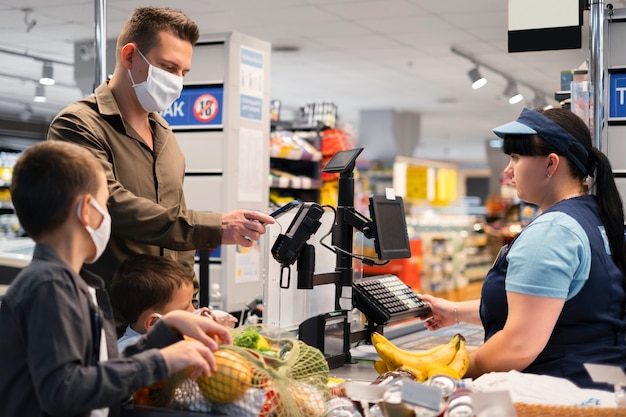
[110, 255, 237, 352]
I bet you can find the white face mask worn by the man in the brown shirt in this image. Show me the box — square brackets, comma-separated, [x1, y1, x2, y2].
[128, 49, 183, 113]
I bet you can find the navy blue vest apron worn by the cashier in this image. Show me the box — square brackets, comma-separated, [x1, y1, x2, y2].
[480, 196, 626, 389]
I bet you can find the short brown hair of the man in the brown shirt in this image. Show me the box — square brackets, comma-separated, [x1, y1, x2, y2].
[116, 7, 200, 56]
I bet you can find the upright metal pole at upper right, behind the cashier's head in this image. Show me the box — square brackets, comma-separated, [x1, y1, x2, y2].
[589, 0, 604, 150]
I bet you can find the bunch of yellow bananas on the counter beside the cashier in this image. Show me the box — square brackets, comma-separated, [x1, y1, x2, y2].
[372, 332, 469, 382]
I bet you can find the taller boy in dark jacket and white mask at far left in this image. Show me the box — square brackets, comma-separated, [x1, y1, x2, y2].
[0, 141, 232, 416]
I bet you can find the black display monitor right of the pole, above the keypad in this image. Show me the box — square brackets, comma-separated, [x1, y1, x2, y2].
[370, 195, 411, 260]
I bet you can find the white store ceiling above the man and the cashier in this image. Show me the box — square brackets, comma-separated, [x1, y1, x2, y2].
[0, 0, 596, 163]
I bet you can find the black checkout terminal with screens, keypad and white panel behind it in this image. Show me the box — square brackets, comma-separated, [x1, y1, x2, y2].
[263, 148, 430, 369]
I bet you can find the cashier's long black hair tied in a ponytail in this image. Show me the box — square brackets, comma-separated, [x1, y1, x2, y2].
[541, 109, 626, 282]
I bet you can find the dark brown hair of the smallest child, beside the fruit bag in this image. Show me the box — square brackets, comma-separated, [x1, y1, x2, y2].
[110, 255, 193, 323]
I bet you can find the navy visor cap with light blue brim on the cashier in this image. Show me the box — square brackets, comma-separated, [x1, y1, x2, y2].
[493, 108, 589, 175]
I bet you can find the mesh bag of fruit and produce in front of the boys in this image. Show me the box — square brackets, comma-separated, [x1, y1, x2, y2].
[132, 325, 330, 417]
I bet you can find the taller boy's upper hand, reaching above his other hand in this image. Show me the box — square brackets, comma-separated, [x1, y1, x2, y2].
[162, 310, 233, 351]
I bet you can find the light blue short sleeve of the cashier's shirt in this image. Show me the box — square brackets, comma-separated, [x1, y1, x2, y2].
[505, 212, 588, 300]
